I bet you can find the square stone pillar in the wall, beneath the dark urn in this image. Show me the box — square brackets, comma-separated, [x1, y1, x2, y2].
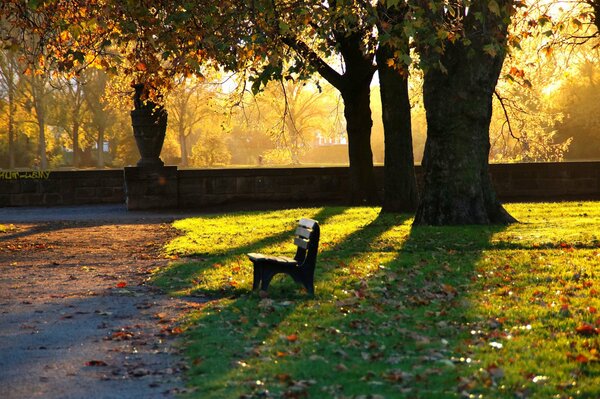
[124, 166, 179, 211]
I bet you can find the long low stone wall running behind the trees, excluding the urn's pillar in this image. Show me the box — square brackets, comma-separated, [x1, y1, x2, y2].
[0, 162, 600, 208]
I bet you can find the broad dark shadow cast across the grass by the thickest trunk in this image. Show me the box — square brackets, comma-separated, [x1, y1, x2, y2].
[268, 217, 505, 398]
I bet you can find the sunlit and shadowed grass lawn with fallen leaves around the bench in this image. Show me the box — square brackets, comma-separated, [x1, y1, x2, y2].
[154, 202, 600, 398]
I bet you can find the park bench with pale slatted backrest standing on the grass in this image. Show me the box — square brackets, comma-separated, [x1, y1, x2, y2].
[247, 218, 320, 295]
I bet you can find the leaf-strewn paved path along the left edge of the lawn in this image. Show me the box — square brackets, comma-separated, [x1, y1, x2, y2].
[0, 205, 202, 399]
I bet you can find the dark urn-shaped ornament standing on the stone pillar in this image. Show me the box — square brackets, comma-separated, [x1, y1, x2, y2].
[131, 83, 167, 167]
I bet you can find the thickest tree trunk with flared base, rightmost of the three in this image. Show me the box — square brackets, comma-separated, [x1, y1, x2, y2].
[414, 29, 516, 225]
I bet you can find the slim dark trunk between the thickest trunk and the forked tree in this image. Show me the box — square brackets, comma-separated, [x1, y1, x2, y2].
[377, 39, 418, 213]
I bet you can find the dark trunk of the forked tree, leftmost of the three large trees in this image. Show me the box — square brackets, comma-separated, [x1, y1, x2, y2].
[341, 82, 379, 205]
